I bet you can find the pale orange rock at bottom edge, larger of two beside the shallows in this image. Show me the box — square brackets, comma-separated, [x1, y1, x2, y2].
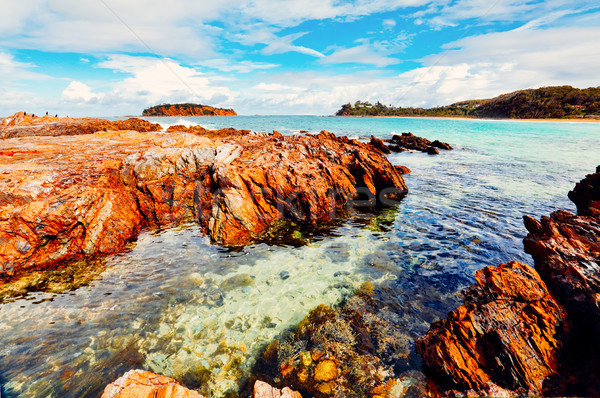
[102, 369, 203, 398]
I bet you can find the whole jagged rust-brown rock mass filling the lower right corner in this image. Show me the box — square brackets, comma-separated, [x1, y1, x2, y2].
[417, 166, 600, 396]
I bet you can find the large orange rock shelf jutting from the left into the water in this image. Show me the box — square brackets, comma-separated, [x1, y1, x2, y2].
[0, 113, 407, 277]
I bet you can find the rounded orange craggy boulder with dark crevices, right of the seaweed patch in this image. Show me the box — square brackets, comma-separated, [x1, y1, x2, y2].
[416, 262, 569, 395]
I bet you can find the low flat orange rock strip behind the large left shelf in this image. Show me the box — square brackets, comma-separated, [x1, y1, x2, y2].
[0, 112, 162, 139]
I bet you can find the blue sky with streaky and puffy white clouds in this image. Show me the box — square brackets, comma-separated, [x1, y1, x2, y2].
[0, 0, 600, 116]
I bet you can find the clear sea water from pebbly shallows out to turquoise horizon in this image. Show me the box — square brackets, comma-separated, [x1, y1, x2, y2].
[0, 116, 600, 397]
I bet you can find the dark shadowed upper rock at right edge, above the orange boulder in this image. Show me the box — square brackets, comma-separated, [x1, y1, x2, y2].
[523, 167, 600, 333]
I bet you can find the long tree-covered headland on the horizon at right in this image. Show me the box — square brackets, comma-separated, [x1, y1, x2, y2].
[336, 86, 600, 119]
